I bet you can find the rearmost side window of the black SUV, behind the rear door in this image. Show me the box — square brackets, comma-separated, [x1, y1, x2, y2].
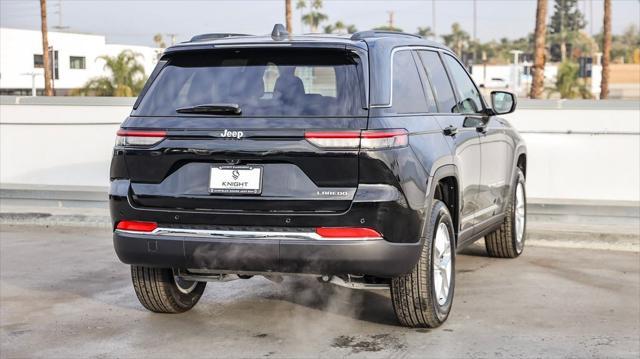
[392, 50, 427, 113]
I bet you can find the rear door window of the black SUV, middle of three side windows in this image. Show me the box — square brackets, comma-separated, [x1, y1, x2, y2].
[418, 51, 456, 113]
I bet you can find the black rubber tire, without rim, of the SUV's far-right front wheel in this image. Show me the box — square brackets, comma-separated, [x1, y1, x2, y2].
[484, 168, 527, 258]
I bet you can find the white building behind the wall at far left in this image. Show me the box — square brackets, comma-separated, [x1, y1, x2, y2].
[0, 27, 161, 95]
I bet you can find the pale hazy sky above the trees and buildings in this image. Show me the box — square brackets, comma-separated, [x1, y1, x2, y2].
[0, 0, 640, 46]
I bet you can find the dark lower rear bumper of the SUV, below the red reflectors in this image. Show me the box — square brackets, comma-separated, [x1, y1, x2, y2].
[113, 230, 422, 277]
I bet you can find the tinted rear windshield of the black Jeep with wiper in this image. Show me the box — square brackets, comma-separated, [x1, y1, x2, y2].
[135, 49, 365, 117]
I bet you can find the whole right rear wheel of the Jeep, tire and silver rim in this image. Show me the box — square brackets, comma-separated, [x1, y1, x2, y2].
[391, 200, 455, 328]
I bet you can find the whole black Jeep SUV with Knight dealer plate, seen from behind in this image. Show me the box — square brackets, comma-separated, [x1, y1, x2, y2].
[109, 25, 527, 327]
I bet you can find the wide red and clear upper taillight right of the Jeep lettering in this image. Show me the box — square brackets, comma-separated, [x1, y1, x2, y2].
[304, 129, 409, 150]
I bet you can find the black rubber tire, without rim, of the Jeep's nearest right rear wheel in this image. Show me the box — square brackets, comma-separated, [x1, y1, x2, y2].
[391, 200, 456, 328]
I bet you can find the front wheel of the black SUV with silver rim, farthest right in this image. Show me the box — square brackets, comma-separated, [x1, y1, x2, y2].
[484, 168, 527, 258]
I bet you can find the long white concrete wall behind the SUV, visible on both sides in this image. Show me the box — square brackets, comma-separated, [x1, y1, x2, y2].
[0, 97, 640, 201]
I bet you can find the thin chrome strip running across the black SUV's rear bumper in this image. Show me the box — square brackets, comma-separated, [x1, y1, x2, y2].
[115, 227, 382, 241]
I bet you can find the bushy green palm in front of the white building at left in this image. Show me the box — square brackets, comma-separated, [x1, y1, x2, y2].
[73, 50, 146, 97]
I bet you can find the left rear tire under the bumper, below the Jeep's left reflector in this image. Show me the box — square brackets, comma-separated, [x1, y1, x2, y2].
[131, 266, 207, 313]
